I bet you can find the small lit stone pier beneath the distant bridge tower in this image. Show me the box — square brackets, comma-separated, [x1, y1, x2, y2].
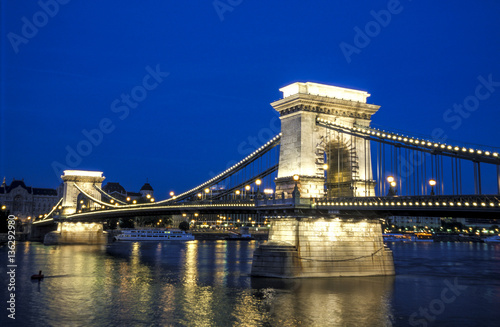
[43, 222, 108, 245]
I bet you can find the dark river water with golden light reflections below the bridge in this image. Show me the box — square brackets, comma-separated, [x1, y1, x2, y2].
[0, 241, 500, 327]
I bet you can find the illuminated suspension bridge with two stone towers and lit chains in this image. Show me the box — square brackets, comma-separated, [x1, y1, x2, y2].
[33, 82, 500, 276]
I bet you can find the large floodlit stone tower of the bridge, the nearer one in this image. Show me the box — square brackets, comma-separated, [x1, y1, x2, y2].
[271, 82, 380, 198]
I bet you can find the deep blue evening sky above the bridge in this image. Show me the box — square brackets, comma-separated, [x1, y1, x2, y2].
[0, 0, 500, 199]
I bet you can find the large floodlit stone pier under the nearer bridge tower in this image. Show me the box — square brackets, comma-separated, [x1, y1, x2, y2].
[251, 218, 395, 278]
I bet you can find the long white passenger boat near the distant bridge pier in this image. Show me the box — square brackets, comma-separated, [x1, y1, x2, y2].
[114, 229, 194, 242]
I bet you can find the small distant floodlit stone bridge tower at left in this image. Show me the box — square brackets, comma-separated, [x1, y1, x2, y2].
[61, 170, 105, 216]
